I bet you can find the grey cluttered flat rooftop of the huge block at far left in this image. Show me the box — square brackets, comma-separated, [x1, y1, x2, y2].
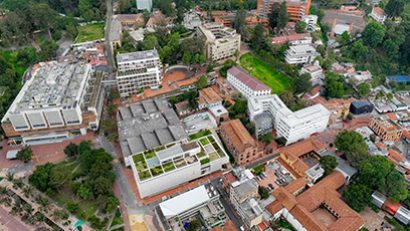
[10, 61, 91, 113]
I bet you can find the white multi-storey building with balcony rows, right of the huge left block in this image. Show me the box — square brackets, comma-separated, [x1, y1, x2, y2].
[117, 50, 163, 97]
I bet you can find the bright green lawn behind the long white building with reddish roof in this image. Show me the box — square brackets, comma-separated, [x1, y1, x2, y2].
[240, 53, 292, 94]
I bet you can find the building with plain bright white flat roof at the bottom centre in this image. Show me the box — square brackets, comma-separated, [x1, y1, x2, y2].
[155, 184, 227, 231]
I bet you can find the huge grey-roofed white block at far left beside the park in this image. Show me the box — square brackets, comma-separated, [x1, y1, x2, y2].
[1, 61, 103, 144]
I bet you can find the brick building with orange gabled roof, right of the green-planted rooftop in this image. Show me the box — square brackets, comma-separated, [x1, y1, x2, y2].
[220, 119, 263, 165]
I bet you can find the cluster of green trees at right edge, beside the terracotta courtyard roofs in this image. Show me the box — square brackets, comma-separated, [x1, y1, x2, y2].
[335, 131, 409, 211]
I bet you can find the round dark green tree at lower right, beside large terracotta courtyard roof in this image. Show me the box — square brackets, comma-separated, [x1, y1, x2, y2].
[343, 184, 371, 212]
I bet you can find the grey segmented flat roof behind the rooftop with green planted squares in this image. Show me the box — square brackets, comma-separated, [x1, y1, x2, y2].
[117, 99, 187, 157]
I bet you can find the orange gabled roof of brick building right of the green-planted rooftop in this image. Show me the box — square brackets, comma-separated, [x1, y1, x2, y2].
[220, 119, 257, 152]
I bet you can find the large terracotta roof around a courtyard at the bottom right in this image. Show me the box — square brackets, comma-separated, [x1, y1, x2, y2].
[266, 171, 364, 231]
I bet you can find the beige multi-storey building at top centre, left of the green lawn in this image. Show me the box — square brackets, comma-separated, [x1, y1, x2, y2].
[197, 23, 241, 61]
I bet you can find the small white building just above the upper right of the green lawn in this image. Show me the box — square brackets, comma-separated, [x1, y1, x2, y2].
[285, 44, 318, 64]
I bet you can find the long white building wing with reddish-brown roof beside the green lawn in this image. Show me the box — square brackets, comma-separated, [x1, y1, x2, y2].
[227, 67, 272, 98]
